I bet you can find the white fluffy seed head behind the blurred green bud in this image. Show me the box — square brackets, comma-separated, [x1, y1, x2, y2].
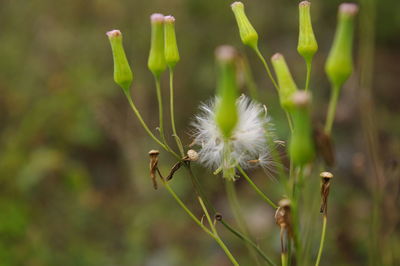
[192, 95, 271, 178]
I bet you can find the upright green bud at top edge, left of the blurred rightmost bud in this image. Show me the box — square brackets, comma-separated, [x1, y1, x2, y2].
[297, 1, 318, 62]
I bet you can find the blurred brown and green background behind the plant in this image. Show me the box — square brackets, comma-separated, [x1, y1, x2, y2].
[0, 0, 400, 266]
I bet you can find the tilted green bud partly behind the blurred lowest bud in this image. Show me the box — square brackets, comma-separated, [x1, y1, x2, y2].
[271, 53, 297, 111]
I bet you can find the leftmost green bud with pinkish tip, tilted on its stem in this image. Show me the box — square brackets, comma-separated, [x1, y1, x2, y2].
[106, 30, 133, 93]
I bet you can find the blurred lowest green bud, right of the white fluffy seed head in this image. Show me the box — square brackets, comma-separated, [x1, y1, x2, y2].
[289, 91, 315, 166]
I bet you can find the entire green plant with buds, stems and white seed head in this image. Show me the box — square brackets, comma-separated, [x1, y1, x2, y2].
[107, 1, 357, 265]
